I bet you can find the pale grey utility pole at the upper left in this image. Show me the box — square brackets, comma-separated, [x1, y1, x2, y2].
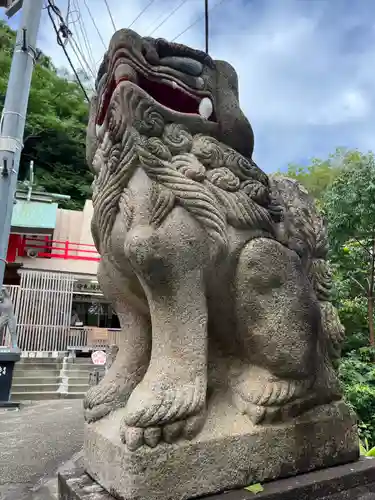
[0, 0, 43, 290]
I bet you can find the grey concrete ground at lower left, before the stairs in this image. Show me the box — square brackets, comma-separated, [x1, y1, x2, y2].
[0, 400, 83, 500]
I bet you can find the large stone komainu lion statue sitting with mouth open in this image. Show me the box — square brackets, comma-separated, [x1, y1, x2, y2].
[85, 30, 343, 450]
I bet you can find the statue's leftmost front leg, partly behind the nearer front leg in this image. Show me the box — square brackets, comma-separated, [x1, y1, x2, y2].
[84, 259, 151, 422]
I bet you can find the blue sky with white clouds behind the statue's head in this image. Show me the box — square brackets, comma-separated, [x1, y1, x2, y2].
[2, 0, 375, 172]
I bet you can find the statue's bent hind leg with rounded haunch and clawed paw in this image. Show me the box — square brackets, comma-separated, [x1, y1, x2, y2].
[231, 238, 321, 423]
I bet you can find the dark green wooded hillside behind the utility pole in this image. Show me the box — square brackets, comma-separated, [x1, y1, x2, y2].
[0, 21, 92, 208]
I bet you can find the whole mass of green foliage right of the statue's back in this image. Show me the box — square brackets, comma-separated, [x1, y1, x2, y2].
[296, 150, 375, 445]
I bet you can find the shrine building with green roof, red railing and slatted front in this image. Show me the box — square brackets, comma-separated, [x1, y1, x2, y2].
[0, 190, 119, 352]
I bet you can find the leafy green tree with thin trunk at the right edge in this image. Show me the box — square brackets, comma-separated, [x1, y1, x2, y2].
[323, 151, 375, 346]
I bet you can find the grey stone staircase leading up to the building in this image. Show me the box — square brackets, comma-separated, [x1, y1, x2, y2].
[11, 356, 104, 401]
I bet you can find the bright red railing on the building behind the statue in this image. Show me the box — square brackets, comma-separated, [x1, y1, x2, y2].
[17, 236, 100, 262]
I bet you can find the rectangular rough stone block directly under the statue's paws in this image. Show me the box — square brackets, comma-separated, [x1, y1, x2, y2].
[84, 396, 359, 500]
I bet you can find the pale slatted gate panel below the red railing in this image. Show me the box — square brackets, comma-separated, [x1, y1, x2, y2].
[14, 270, 75, 351]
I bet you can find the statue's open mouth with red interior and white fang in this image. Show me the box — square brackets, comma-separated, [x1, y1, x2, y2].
[96, 60, 216, 127]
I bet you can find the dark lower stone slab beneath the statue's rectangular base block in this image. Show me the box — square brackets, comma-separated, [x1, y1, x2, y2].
[58, 458, 375, 500]
